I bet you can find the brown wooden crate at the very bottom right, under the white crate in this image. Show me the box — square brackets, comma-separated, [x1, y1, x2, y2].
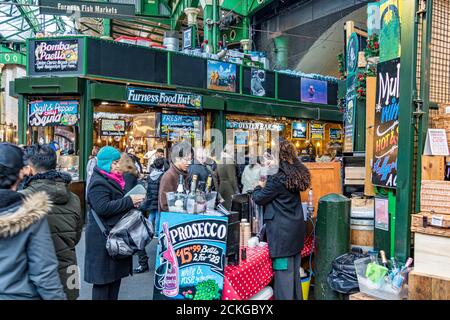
[408, 270, 450, 300]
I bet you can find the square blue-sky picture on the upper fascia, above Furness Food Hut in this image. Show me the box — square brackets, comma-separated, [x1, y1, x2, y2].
[207, 60, 237, 92]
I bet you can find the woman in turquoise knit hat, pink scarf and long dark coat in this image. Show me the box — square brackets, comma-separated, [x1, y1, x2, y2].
[84, 146, 143, 300]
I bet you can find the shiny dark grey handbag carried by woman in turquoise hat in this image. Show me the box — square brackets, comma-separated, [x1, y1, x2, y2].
[91, 209, 154, 259]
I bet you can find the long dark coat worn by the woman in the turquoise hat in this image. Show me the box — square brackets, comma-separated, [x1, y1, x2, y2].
[84, 168, 134, 284]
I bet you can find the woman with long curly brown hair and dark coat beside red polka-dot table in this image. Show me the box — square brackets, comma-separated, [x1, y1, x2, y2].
[253, 138, 311, 300]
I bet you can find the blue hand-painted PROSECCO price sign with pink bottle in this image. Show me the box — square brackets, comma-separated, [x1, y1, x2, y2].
[153, 212, 228, 300]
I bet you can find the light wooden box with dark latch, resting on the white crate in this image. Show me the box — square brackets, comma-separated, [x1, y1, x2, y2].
[411, 212, 450, 237]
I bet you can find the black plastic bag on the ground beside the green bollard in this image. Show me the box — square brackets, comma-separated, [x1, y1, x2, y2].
[327, 252, 369, 294]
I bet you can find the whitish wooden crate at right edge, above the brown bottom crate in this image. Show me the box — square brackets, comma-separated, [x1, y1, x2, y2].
[414, 232, 450, 278]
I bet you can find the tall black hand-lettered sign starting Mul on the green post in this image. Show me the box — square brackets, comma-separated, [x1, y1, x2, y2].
[372, 59, 400, 188]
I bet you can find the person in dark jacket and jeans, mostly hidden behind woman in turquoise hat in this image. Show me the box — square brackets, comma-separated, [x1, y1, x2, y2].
[134, 158, 168, 273]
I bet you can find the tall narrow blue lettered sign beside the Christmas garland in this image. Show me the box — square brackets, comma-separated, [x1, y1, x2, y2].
[343, 74, 356, 152]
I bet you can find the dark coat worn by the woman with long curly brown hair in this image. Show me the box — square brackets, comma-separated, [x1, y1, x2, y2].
[252, 173, 306, 258]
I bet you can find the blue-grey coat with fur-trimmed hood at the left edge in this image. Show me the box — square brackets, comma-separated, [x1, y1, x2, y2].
[0, 190, 66, 300]
